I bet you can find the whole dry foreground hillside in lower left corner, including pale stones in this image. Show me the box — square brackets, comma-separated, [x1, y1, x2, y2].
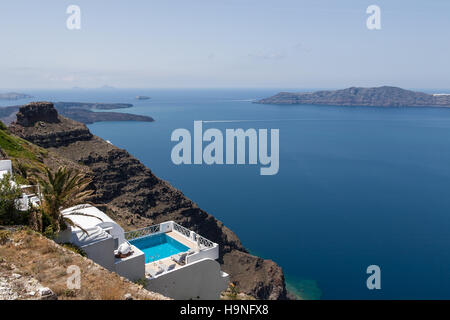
[0, 229, 168, 300]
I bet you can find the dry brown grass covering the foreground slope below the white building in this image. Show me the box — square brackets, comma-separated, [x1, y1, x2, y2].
[0, 230, 166, 300]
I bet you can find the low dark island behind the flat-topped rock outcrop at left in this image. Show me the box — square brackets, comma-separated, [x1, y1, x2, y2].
[0, 102, 154, 124]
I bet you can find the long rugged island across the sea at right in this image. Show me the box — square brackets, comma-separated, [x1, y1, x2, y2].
[254, 86, 450, 107]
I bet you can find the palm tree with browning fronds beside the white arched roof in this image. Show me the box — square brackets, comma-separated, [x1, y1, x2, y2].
[37, 167, 103, 233]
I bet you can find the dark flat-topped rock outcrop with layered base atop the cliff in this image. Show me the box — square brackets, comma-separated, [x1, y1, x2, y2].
[9, 102, 92, 148]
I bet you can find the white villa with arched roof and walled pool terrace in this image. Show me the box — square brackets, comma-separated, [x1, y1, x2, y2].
[57, 205, 229, 299]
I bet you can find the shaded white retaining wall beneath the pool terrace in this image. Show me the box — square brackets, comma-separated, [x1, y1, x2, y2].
[147, 259, 229, 300]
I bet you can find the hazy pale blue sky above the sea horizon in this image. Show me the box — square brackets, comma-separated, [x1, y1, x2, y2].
[0, 0, 450, 91]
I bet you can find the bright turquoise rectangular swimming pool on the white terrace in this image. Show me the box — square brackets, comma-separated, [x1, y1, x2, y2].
[130, 233, 189, 263]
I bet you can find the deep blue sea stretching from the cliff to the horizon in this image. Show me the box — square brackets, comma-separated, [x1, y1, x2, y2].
[2, 88, 450, 299]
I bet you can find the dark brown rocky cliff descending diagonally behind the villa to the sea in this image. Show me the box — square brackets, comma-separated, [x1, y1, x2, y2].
[10, 103, 286, 299]
